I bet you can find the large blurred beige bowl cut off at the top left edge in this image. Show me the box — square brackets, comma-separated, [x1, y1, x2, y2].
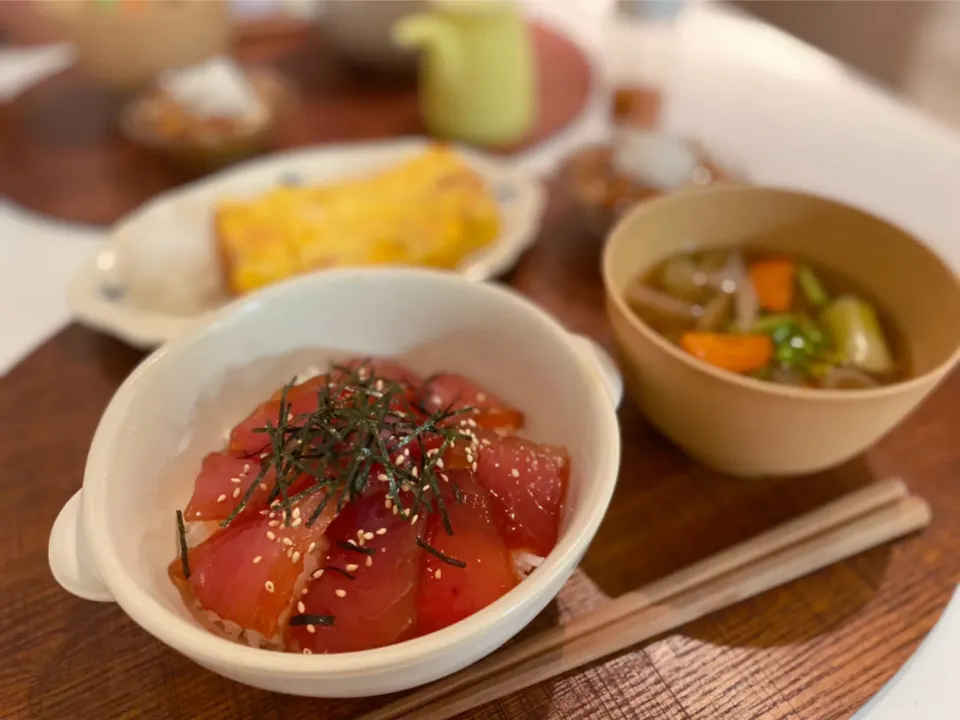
[36, 0, 232, 91]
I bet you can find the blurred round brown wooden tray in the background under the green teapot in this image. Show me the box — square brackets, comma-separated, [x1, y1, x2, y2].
[0, 23, 591, 224]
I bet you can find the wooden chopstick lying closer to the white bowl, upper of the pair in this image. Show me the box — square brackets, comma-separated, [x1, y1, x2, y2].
[361, 479, 907, 720]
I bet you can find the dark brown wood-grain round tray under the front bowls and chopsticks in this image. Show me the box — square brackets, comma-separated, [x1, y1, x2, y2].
[0, 8, 960, 720]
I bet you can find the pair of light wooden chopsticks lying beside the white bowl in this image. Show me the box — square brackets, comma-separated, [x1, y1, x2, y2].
[359, 479, 930, 720]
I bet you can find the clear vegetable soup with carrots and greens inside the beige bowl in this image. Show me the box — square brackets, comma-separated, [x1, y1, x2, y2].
[625, 248, 907, 390]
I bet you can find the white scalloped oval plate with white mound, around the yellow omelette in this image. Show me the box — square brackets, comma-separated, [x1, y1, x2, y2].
[70, 137, 546, 348]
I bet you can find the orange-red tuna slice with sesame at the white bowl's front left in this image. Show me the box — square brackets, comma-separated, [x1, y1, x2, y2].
[170, 493, 335, 643]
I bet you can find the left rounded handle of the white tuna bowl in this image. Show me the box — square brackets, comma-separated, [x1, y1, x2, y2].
[47, 490, 113, 602]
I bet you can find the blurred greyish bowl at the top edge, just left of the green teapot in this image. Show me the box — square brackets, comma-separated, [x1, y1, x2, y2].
[320, 0, 428, 74]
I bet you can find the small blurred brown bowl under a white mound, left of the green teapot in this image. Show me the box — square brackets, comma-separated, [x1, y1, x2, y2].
[120, 68, 288, 175]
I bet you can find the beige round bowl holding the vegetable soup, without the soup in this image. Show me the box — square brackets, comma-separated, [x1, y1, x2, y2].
[603, 185, 960, 477]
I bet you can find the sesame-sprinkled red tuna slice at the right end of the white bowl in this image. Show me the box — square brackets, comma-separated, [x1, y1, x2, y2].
[477, 433, 570, 556]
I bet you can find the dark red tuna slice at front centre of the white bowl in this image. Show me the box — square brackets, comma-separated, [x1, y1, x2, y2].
[287, 489, 425, 653]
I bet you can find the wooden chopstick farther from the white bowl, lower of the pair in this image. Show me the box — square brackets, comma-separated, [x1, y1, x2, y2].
[412, 497, 930, 720]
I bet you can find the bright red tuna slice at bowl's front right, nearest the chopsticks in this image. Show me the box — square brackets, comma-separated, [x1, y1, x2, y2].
[417, 470, 518, 634]
